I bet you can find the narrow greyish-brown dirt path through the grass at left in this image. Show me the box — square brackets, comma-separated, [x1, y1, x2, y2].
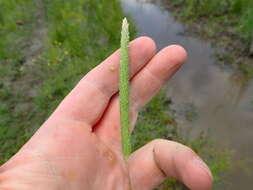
[12, 0, 47, 116]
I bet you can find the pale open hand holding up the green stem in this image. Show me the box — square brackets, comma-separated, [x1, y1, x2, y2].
[0, 37, 212, 190]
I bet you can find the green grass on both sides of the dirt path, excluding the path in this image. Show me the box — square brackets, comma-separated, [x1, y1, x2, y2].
[0, 0, 123, 163]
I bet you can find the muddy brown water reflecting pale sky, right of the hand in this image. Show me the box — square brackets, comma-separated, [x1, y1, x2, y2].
[121, 0, 253, 190]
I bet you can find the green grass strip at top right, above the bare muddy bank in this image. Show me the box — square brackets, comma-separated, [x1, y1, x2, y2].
[170, 0, 253, 41]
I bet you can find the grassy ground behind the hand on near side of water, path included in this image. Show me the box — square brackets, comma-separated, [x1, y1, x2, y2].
[0, 0, 229, 188]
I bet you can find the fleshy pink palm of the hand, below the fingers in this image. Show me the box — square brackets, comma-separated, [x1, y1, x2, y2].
[0, 120, 129, 190]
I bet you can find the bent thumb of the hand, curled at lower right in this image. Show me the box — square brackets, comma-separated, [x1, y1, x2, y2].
[128, 139, 213, 190]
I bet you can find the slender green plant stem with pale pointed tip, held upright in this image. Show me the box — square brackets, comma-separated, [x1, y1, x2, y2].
[119, 18, 131, 157]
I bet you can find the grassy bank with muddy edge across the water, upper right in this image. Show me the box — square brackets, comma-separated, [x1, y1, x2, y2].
[168, 0, 253, 77]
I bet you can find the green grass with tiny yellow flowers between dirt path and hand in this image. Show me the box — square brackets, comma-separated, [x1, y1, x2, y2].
[36, 0, 123, 118]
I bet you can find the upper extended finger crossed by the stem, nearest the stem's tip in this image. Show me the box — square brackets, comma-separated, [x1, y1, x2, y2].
[53, 37, 156, 126]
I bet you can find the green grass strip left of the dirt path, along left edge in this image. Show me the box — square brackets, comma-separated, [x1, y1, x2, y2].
[0, 0, 34, 163]
